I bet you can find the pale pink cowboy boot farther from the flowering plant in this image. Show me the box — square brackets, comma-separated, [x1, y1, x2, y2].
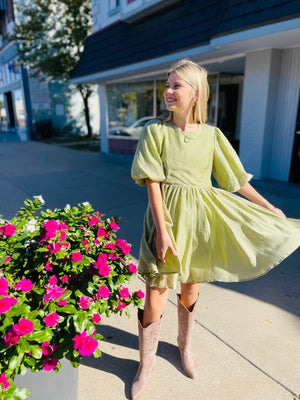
[177, 294, 198, 378]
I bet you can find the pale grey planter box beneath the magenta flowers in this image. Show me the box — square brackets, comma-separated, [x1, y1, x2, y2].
[14, 360, 78, 400]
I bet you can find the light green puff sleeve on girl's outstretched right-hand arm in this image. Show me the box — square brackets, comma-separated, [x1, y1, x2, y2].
[212, 128, 253, 192]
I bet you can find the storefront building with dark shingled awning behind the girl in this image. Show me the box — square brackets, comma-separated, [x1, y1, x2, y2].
[73, 0, 300, 182]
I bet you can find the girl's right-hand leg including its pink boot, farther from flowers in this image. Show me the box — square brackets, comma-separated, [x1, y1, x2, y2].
[177, 283, 199, 378]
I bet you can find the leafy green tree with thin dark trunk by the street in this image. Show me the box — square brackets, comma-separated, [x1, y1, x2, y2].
[11, 0, 92, 137]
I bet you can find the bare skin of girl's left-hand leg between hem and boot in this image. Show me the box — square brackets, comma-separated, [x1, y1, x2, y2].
[143, 286, 169, 328]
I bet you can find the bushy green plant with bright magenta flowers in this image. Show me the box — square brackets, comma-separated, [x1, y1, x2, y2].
[0, 196, 144, 400]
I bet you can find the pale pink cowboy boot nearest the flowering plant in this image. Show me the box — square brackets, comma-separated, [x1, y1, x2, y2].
[131, 310, 163, 400]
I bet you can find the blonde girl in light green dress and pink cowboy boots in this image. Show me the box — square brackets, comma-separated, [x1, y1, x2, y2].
[131, 60, 300, 400]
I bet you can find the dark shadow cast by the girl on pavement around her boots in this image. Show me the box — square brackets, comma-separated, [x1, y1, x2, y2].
[81, 325, 184, 399]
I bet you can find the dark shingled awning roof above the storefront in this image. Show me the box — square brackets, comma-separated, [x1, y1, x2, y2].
[72, 0, 300, 78]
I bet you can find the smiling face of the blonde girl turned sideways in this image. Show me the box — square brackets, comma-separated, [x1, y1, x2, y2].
[164, 72, 197, 114]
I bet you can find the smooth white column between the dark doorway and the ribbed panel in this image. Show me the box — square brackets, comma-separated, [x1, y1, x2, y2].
[239, 49, 281, 179]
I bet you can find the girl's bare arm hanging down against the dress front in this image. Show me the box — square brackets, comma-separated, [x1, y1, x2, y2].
[146, 179, 177, 263]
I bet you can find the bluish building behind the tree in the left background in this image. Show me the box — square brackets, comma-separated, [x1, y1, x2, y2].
[0, 0, 99, 140]
